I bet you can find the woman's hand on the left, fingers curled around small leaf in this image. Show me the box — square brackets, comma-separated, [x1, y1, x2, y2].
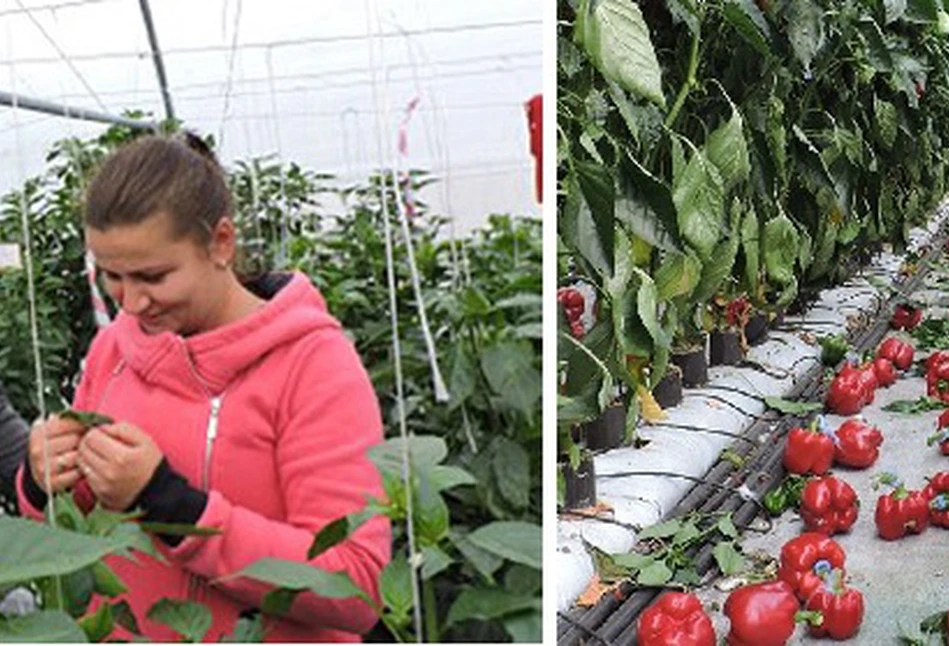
[29, 415, 86, 495]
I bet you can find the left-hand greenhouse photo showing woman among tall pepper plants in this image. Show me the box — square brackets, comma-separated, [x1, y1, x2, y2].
[0, 0, 543, 642]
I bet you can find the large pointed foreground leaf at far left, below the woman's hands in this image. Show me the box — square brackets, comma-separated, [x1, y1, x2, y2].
[0, 516, 130, 585]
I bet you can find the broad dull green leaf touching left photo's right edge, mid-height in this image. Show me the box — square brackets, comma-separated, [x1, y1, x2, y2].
[481, 341, 541, 418]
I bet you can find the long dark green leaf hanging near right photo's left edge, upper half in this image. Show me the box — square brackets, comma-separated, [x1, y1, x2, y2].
[574, 161, 616, 276]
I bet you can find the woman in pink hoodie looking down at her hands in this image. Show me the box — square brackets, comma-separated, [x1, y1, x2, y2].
[13, 137, 391, 642]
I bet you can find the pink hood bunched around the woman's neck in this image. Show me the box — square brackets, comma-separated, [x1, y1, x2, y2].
[113, 272, 340, 397]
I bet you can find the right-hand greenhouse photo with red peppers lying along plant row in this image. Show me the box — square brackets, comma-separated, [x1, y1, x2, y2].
[547, 0, 949, 646]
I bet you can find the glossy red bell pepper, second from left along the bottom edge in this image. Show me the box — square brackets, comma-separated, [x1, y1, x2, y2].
[725, 581, 800, 646]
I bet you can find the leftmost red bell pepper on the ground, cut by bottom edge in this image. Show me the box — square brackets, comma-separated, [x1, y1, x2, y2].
[636, 592, 715, 646]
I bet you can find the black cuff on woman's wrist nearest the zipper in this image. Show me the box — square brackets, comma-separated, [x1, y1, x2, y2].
[129, 458, 208, 546]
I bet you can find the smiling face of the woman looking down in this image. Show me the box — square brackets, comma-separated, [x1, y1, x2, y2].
[86, 213, 229, 336]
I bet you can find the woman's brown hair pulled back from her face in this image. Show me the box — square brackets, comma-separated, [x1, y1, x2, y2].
[84, 133, 232, 244]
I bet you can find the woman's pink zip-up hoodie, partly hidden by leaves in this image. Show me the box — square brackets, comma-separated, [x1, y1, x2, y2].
[18, 273, 391, 642]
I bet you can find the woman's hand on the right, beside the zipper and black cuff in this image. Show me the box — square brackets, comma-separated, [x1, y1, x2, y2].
[79, 422, 164, 511]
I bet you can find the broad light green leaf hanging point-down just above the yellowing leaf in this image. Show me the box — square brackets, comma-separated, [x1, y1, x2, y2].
[672, 150, 724, 261]
